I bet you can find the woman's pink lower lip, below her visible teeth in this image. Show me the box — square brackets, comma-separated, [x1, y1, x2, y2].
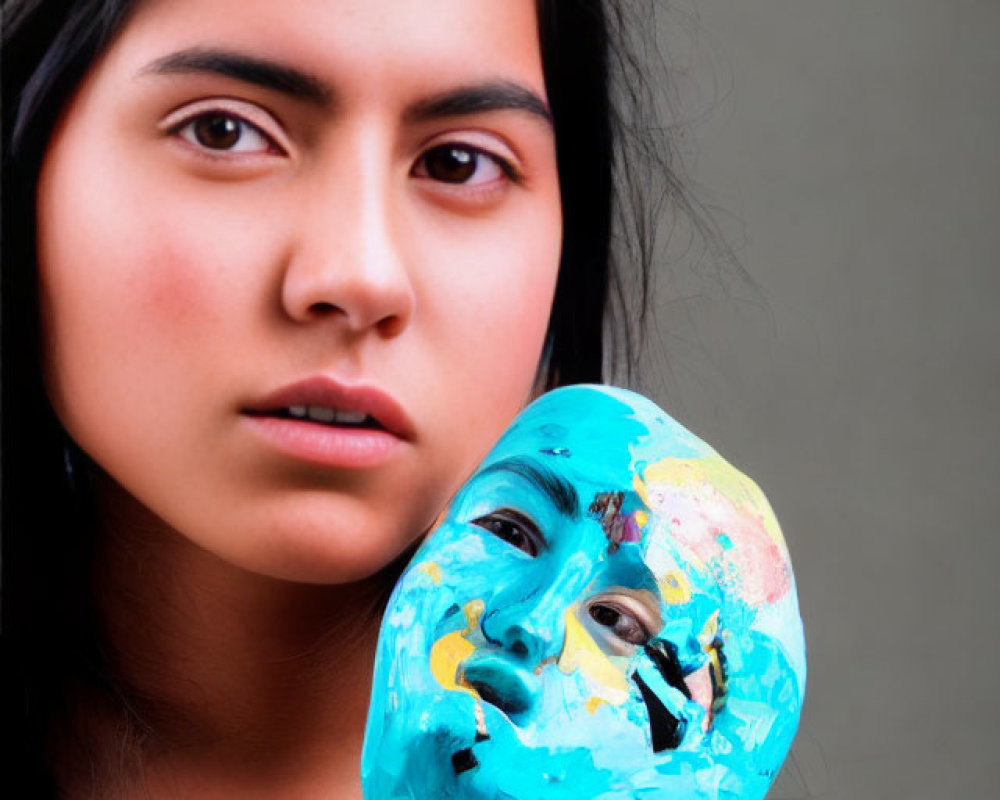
[243, 415, 403, 469]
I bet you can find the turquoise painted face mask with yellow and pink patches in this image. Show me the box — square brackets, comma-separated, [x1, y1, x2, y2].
[362, 386, 806, 800]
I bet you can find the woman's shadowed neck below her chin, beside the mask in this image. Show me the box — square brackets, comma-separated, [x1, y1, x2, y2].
[60, 472, 392, 798]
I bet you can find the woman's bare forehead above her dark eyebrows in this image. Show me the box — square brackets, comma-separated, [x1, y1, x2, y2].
[113, 0, 544, 100]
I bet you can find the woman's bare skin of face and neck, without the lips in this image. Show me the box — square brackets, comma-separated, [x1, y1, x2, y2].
[37, 0, 561, 798]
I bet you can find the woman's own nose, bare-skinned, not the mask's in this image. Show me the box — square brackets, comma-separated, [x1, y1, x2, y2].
[281, 152, 415, 337]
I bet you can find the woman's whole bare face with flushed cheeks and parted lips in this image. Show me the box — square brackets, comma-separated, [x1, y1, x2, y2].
[38, 0, 561, 581]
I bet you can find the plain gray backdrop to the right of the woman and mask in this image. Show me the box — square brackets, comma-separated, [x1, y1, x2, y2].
[642, 0, 1000, 800]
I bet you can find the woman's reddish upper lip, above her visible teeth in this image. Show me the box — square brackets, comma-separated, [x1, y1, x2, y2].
[243, 375, 415, 439]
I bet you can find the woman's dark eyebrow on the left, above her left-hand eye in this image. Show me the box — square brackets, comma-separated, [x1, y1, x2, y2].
[142, 47, 333, 107]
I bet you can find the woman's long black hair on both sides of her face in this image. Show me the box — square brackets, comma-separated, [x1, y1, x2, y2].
[0, 0, 696, 794]
